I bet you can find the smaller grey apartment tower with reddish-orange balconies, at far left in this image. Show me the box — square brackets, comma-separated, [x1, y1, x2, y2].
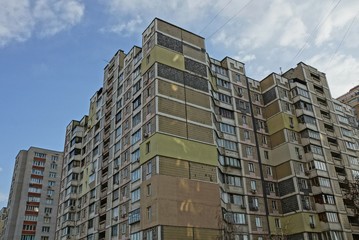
[4, 147, 63, 240]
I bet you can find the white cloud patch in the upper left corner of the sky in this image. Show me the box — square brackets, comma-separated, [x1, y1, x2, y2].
[0, 0, 84, 46]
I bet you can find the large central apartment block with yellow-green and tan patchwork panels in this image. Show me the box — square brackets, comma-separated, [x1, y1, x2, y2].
[55, 19, 359, 240]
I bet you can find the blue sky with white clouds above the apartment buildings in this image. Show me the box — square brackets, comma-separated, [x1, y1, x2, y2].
[0, 0, 359, 207]
